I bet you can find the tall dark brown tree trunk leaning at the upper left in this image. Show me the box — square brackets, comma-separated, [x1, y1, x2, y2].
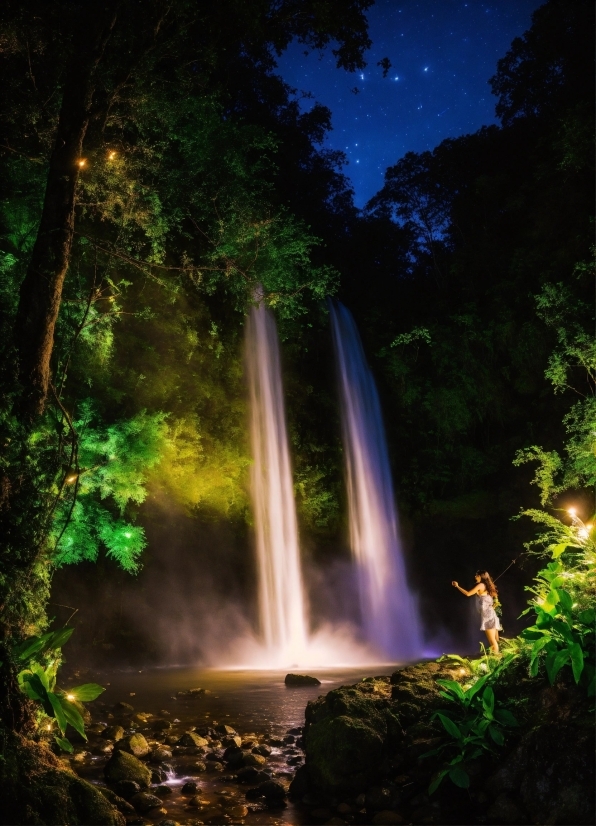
[14, 2, 120, 419]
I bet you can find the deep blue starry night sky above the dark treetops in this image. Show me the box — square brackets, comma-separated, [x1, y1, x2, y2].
[278, 0, 542, 207]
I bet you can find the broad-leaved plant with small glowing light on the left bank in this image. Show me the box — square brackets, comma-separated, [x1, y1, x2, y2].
[13, 628, 105, 753]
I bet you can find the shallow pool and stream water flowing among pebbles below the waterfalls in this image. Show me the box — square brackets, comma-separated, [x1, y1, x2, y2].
[71, 665, 397, 826]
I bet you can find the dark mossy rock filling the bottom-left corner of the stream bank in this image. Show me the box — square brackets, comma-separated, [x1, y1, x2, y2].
[0, 732, 125, 826]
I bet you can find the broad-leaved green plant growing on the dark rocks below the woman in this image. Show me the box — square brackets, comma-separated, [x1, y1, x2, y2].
[420, 654, 518, 794]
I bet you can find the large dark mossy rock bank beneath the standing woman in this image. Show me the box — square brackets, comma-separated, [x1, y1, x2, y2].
[290, 660, 594, 826]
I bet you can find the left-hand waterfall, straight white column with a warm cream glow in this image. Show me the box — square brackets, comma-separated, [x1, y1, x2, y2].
[246, 302, 308, 665]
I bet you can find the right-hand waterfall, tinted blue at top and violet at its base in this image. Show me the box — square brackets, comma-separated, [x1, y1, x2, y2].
[330, 302, 422, 659]
